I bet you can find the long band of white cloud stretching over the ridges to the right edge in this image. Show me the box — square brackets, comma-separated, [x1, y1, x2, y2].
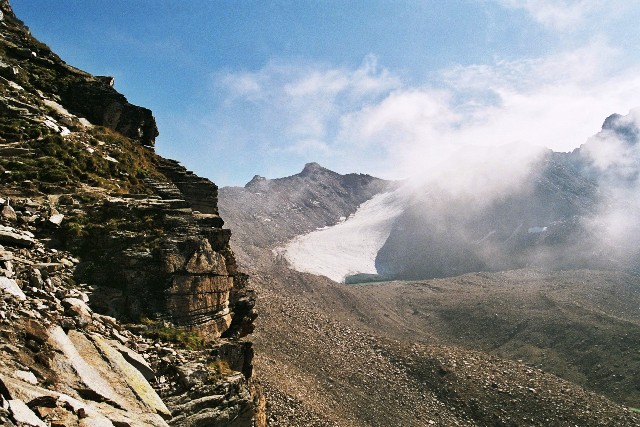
[210, 39, 640, 189]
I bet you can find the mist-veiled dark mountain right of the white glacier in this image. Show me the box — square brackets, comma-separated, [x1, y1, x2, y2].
[376, 110, 639, 279]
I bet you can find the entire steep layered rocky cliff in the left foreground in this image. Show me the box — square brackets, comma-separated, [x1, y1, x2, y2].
[0, 0, 264, 426]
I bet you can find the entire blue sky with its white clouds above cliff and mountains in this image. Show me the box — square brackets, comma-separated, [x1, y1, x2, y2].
[11, 0, 640, 186]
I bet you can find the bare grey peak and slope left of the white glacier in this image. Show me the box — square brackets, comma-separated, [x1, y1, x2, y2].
[220, 163, 395, 266]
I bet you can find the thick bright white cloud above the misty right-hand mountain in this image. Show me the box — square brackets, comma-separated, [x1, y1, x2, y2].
[328, 41, 640, 187]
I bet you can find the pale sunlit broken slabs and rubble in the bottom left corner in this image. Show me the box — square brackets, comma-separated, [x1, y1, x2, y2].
[0, 210, 171, 426]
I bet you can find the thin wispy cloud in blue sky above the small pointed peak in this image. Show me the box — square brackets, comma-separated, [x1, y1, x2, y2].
[216, 56, 400, 160]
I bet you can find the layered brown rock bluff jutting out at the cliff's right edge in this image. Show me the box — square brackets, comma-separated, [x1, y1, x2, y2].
[80, 163, 255, 339]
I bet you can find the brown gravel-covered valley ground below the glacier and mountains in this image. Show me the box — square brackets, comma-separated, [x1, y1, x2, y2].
[242, 263, 640, 426]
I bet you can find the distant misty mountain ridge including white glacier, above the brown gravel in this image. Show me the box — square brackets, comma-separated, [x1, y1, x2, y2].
[229, 110, 640, 282]
